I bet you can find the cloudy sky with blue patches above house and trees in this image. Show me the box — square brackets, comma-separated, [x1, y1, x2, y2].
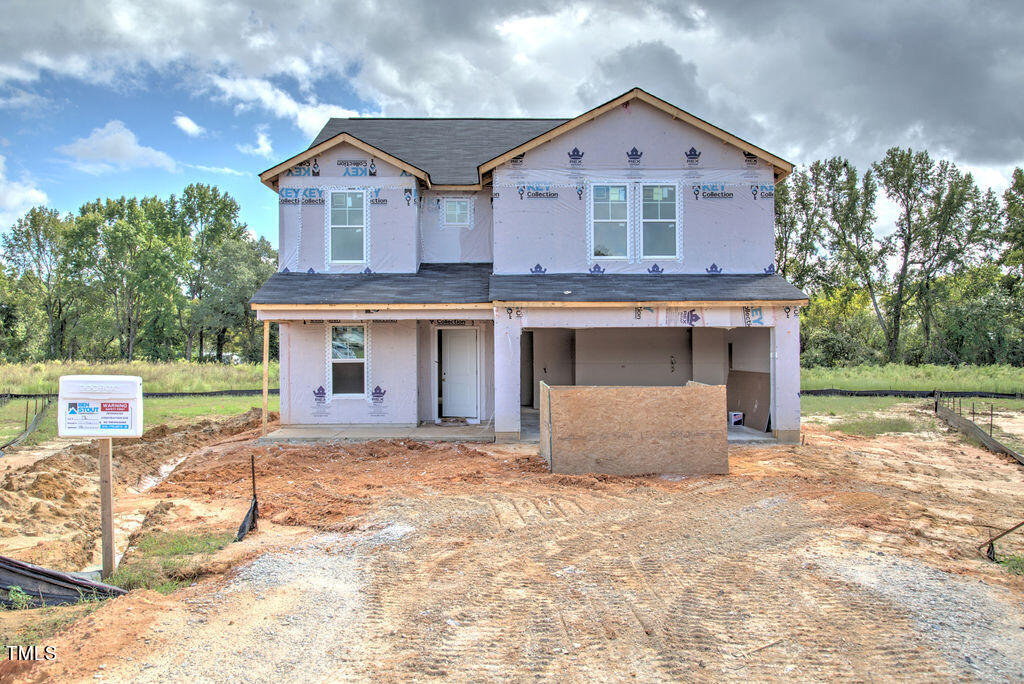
[0, 0, 1024, 244]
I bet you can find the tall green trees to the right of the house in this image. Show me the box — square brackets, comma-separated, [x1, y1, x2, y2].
[775, 147, 1024, 366]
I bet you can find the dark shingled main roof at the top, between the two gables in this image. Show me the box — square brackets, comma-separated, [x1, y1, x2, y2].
[309, 118, 568, 185]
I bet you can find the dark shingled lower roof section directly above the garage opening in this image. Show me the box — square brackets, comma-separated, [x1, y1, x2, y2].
[490, 273, 807, 302]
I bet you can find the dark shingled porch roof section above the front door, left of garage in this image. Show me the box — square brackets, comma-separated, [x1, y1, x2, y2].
[250, 263, 493, 304]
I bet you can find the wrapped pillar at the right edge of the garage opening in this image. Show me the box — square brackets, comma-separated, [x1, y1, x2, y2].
[771, 307, 800, 444]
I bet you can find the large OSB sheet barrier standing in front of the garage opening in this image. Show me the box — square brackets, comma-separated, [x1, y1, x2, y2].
[541, 384, 729, 475]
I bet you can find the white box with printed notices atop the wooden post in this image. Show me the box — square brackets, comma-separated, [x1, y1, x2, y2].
[57, 375, 142, 437]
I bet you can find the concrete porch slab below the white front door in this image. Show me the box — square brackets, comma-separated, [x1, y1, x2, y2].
[256, 423, 495, 444]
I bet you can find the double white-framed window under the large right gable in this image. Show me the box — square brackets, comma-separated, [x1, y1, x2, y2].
[590, 182, 678, 259]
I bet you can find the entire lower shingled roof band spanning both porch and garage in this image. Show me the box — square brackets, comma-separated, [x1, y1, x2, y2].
[250, 263, 807, 304]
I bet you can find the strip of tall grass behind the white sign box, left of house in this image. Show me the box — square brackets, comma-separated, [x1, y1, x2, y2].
[0, 361, 279, 395]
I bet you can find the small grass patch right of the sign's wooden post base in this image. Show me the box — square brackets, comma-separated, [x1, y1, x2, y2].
[108, 531, 234, 594]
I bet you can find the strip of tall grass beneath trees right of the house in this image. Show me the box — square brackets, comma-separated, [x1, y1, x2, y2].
[801, 364, 1024, 393]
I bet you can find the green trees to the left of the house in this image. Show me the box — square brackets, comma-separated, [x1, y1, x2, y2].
[0, 183, 278, 361]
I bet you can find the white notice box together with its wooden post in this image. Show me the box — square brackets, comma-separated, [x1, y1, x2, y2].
[57, 375, 142, 579]
